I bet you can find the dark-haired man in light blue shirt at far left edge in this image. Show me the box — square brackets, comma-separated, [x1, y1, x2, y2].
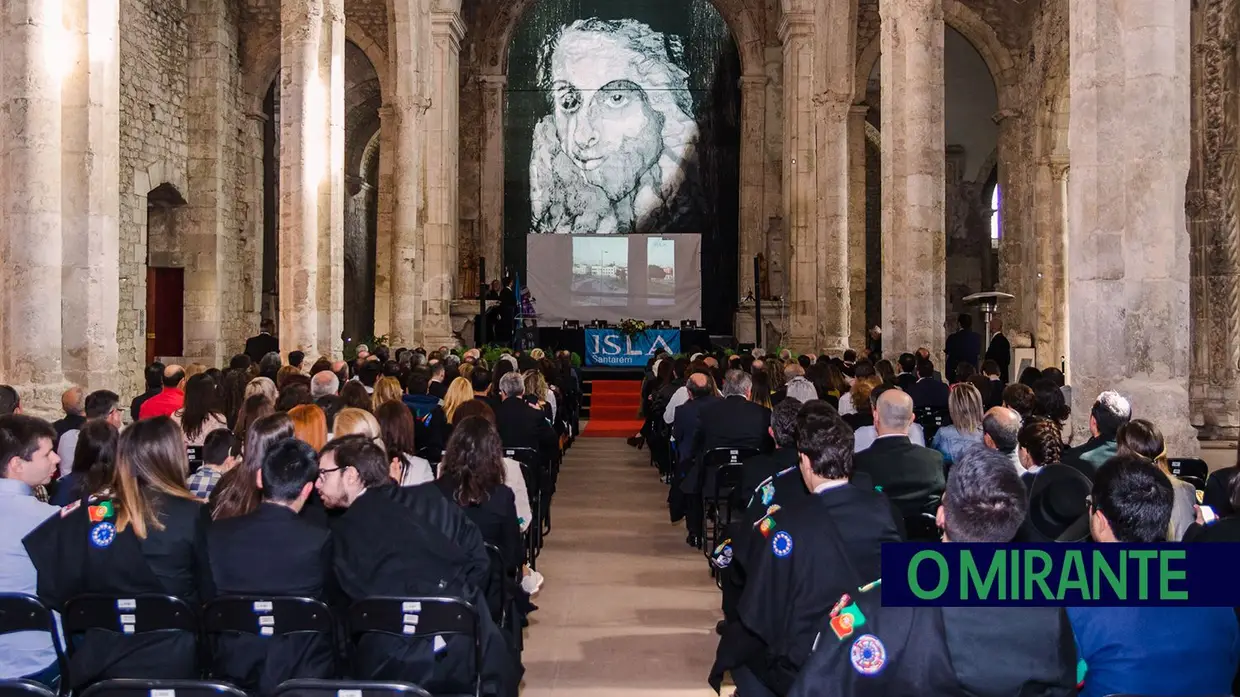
[0, 414, 61, 687]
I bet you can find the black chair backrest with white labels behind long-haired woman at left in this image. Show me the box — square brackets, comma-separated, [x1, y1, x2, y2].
[61, 594, 198, 654]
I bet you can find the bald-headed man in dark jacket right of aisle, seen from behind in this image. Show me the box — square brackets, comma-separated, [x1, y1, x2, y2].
[853, 389, 945, 517]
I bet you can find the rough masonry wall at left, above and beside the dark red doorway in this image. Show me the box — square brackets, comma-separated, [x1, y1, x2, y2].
[117, 0, 188, 398]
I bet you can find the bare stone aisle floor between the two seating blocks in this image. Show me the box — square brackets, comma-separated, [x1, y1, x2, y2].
[521, 438, 730, 697]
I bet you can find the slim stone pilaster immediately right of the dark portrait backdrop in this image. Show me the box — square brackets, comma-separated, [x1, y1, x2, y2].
[735, 74, 769, 305]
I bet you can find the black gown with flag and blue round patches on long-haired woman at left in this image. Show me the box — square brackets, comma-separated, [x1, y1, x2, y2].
[22, 494, 215, 690]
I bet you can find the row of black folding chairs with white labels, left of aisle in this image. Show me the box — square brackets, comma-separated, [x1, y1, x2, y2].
[0, 594, 483, 697]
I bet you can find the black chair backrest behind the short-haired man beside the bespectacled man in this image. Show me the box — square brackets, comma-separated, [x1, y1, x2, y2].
[202, 595, 335, 636]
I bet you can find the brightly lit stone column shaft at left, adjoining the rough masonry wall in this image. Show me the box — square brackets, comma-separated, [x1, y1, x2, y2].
[61, 0, 120, 391]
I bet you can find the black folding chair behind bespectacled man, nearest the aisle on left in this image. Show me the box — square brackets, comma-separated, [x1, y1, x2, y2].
[347, 597, 482, 697]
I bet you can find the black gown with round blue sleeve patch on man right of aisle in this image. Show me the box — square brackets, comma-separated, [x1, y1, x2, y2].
[711, 484, 900, 695]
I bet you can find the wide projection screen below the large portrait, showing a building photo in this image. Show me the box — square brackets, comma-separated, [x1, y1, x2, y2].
[526, 234, 702, 326]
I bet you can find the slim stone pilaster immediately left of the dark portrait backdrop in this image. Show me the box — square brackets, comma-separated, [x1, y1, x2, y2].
[479, 74, 508, 284]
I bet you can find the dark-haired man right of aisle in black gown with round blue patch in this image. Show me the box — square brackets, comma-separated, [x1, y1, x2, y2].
[711, 393, 902, 697]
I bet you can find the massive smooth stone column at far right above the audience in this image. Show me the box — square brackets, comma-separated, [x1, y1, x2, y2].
[1068, 0, 1198, 456]
